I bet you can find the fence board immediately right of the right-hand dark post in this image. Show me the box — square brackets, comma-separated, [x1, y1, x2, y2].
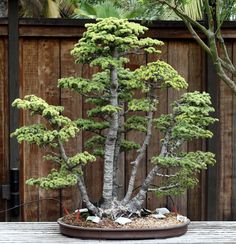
[218, 43, 233, 220]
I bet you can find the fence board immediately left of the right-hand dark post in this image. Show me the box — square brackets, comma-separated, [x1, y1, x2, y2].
[187, 42, 205, 220]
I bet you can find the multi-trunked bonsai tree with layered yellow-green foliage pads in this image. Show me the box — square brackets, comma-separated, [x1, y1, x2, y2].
[12, 18, 216, 218]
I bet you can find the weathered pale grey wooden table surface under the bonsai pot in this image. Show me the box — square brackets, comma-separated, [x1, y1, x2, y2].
[0, 221, 236, 244]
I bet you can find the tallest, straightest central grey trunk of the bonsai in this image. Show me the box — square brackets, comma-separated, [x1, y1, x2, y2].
[102, 49, 119, 208]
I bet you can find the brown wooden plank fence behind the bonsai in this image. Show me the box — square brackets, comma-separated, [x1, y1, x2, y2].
[0, 20, 236, 221]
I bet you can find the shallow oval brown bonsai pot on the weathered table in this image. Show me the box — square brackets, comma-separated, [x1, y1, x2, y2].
[57, 218, 190, 240]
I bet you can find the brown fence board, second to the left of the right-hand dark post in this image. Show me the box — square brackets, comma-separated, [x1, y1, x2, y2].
[168, 41, 189, 215]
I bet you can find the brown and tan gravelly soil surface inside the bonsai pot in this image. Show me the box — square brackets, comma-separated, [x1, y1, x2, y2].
[62, 213, 182, 229]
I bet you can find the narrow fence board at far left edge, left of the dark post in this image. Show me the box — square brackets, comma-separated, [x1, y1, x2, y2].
[0, 38, 9, 221]
